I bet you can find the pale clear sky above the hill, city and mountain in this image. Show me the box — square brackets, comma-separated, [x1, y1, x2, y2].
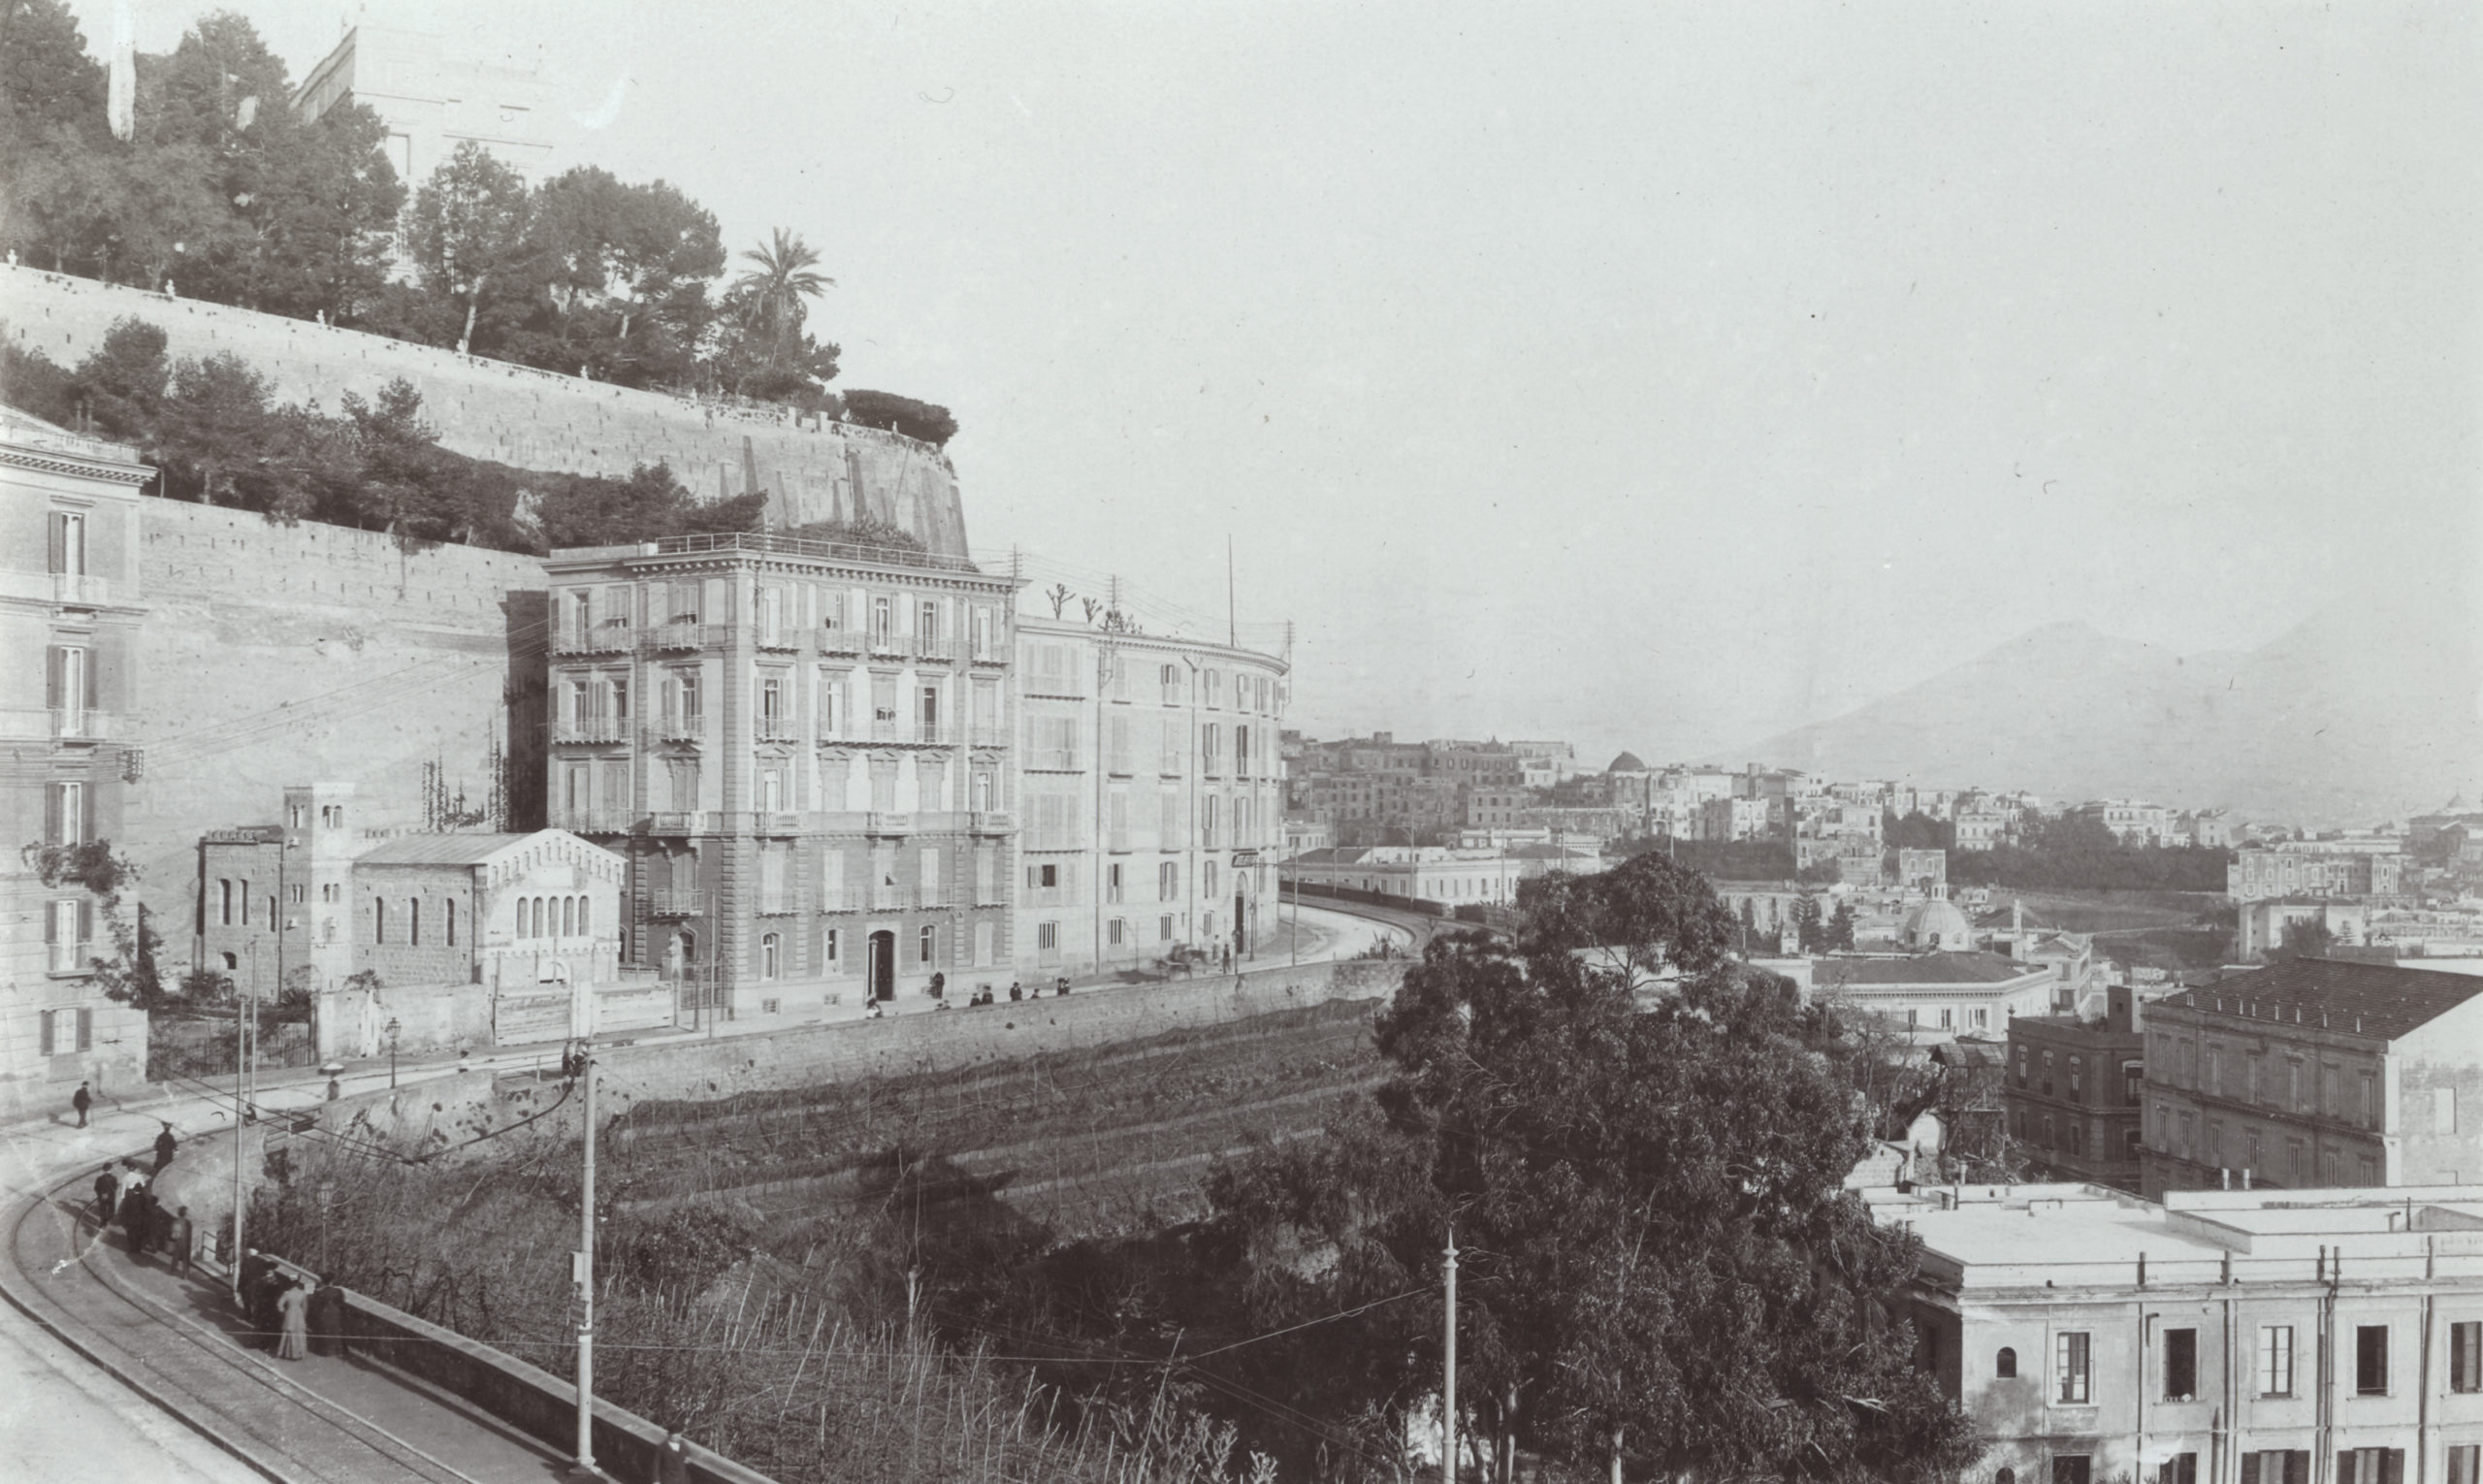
[72, 0, 2483, 764]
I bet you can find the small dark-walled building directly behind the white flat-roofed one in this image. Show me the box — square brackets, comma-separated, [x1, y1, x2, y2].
[2001, 985, 2147, 1194]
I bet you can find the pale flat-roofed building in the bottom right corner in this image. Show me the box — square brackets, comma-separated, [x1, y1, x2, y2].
[1862, 1183, 2483, 1484]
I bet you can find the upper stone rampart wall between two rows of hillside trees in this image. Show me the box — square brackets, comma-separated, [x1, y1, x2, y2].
[0, 263, 968, 556]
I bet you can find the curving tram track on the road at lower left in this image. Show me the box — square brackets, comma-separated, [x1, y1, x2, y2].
[0, 1164, 489, 1484]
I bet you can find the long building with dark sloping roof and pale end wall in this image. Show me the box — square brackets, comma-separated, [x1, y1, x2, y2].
[2143, 958, 2483, 1194]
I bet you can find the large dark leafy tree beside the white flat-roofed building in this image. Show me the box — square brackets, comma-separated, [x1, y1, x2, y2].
[1214, 856, 1972, 1479]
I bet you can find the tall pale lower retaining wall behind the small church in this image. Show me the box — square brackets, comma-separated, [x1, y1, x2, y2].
[116, 499, 549, 968]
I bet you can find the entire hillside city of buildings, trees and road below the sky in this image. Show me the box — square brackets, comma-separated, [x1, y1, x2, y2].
[0, 0, 2483, 1484]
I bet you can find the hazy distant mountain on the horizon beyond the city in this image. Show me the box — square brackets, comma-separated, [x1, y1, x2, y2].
[1719, 610, 2483, 823]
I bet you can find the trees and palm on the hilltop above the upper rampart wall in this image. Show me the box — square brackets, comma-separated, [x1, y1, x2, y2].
[0, 0, 956, 444]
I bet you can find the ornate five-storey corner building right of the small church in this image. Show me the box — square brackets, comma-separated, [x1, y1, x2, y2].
[544, 533, 1017, 1017]
